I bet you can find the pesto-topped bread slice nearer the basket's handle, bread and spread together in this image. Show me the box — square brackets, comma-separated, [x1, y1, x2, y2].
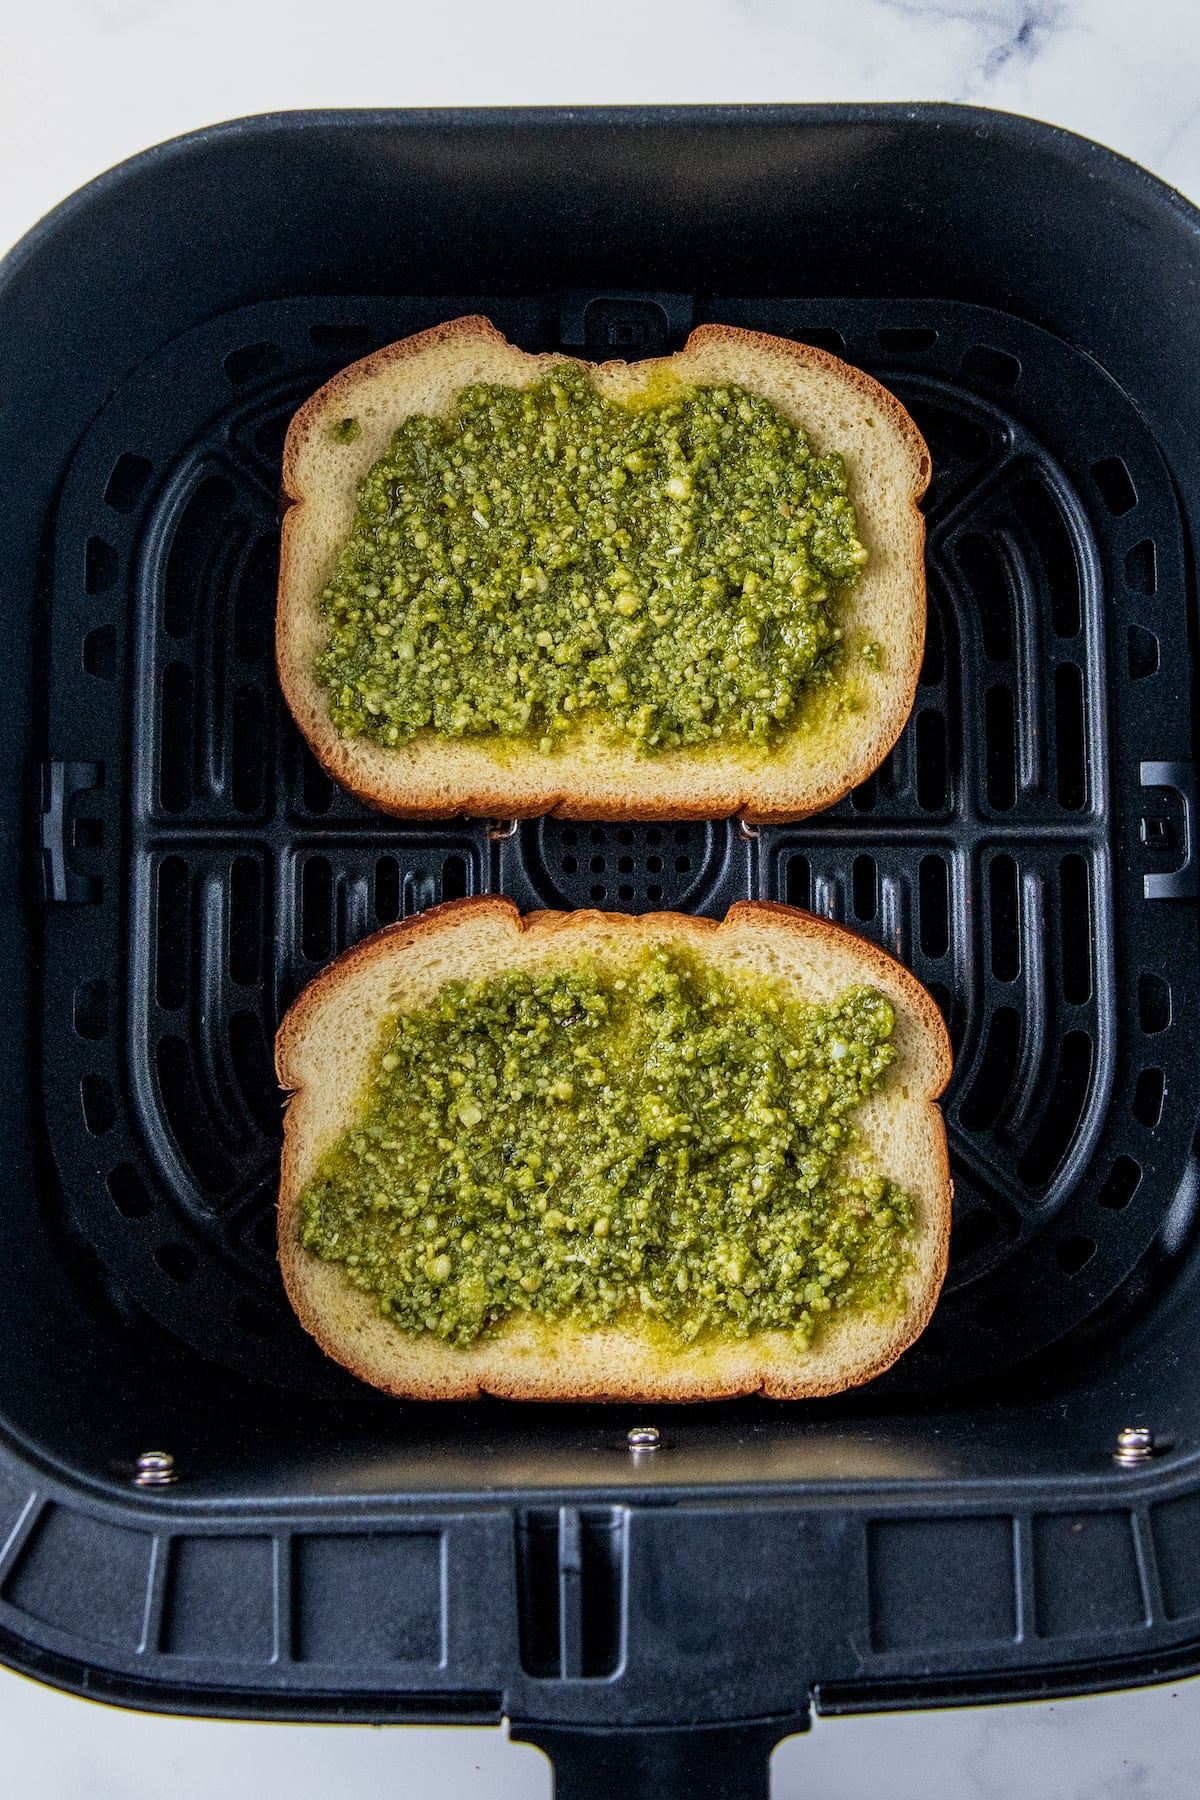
[275, 898, 950, 1400]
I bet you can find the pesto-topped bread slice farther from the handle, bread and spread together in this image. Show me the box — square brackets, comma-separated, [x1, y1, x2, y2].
[275, 319, 930, 821]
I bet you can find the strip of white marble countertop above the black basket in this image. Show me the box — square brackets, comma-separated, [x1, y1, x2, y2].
[0, 0, 1200, 261]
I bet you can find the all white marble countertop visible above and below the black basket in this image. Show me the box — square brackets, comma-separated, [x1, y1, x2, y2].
[0, 0, 1200, 1800]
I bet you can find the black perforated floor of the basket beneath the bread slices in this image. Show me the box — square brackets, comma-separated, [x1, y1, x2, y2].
[41, 295, 1200, 1393]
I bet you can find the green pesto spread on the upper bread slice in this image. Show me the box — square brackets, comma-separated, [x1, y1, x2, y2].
[317, 364, 867, 752]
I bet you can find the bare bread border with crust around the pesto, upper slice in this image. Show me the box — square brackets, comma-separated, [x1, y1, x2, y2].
[275, 319, 930, 823]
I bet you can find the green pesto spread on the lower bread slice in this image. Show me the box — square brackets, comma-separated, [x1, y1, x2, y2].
[299, 947, 912, 1346]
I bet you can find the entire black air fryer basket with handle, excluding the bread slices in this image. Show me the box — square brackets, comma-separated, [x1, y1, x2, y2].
[0, 106, 1200, 1795]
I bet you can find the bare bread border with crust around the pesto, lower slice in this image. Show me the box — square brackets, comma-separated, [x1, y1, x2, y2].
[275, 898, 950, 1400]
